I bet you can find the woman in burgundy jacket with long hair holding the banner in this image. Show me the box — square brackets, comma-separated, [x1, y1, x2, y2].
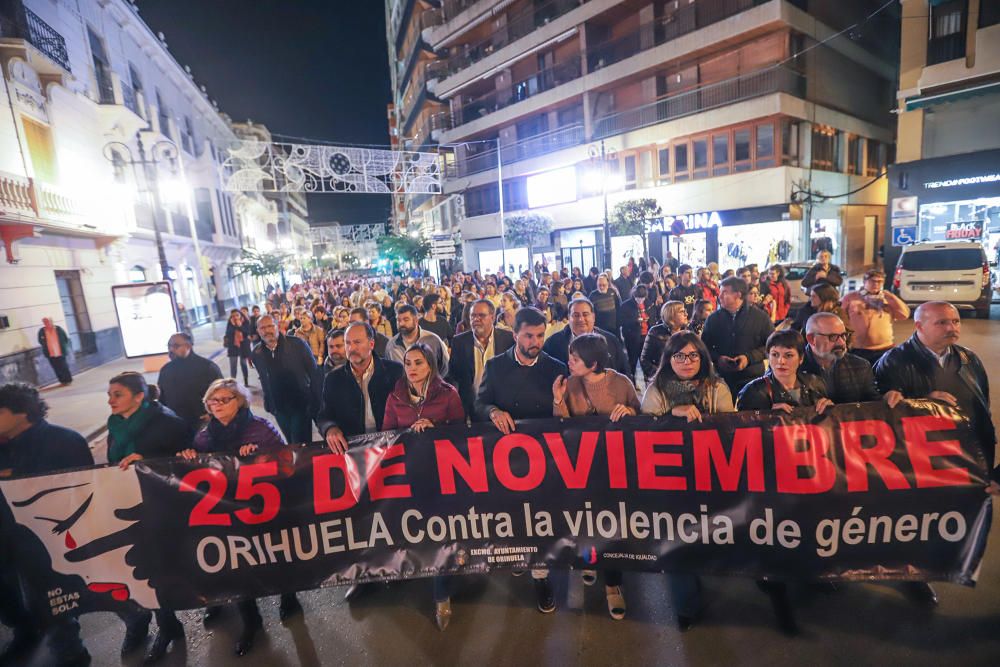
[382, 342, 465, 631]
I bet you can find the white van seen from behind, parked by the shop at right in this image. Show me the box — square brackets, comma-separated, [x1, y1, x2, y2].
[892, 241, 992, 319]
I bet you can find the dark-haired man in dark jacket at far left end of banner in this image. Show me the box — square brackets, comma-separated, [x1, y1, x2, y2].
[0, 382, 94, 665]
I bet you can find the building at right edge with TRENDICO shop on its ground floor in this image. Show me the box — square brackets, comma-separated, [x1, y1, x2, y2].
[885, 0, 1000, 272]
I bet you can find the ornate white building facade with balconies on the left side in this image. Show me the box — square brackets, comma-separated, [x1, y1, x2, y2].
[0, 0, 300, 384]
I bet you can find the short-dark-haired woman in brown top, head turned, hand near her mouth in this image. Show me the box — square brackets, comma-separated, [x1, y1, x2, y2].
[552, 333, 639, 621]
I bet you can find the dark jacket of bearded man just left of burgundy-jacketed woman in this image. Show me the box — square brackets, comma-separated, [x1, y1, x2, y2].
[316, 356, 403, 437]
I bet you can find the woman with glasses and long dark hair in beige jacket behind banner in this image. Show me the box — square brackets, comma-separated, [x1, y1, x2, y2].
[642, 331, 734, 631]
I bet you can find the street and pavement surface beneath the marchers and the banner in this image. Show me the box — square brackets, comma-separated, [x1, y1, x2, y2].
[0, 308, 1000, 667]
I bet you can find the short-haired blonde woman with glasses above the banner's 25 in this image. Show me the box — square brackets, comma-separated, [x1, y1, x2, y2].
[176, 380, 302, 656]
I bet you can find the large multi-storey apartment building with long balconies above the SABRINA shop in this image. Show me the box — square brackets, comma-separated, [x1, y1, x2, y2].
[386, 0, 898, 272]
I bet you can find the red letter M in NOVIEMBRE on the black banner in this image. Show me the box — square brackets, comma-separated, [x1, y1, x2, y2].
[691, 428, 764, 491]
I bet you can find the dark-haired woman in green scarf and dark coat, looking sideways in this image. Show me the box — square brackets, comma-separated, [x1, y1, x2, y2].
[108, 370, 194, 662]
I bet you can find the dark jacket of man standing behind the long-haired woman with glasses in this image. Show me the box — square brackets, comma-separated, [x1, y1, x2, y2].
[701, 302, 774, 394]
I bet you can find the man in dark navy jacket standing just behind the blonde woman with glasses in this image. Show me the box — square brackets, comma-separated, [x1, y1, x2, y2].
[253, 315, 319, 444]
